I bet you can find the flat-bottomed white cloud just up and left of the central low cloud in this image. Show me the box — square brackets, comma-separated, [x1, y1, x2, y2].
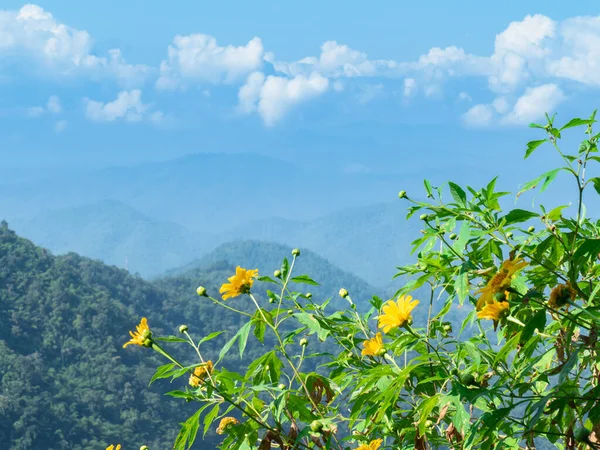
[156, 34, 264, 89]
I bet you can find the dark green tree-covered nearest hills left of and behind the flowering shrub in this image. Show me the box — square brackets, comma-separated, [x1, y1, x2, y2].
[0, 222, 384, 450]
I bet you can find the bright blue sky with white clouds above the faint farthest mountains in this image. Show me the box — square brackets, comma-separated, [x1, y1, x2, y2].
[0, 0, 600, 178]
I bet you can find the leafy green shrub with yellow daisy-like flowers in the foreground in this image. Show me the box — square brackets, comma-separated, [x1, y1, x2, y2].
[119, 113, 600, 450]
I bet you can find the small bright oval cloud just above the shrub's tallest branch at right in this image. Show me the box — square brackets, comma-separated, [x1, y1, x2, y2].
[503, 84, 566, 125]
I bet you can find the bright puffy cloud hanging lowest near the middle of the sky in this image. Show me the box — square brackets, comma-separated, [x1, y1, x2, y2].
[238, 72, 329, 126]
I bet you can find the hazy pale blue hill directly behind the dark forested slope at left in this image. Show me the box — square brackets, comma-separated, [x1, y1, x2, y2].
[11, 200, 211, 276]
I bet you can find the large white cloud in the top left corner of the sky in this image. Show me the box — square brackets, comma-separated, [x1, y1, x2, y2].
[0, 4, 149, 85]
